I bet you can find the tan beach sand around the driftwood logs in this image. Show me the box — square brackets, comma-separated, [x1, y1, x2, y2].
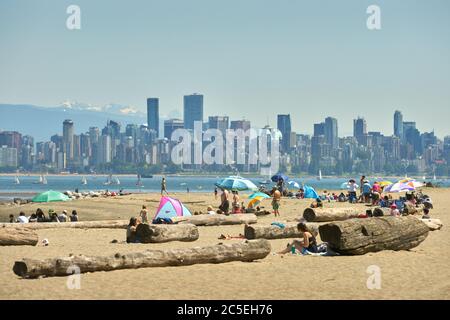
[0, 189, 450, 300]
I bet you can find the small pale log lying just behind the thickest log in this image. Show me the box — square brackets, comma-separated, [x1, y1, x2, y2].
[303, 207, 365, 222]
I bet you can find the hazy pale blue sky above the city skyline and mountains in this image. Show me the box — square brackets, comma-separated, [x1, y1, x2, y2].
[0, 0, 450, 137]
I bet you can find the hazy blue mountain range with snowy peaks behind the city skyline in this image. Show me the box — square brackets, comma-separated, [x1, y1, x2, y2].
[0, 101, 164, 142]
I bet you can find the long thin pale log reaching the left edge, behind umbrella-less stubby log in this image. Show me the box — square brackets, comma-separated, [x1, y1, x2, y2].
[0, 220, 129, 230]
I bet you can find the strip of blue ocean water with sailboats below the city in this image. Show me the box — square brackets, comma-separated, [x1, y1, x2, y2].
[0, 175, 450, 200]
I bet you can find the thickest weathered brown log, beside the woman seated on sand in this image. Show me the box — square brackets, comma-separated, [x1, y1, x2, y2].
[319, 216, 428, 255]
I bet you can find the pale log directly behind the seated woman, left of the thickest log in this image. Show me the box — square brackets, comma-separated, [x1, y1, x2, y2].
[244, 223, 319, 239]
